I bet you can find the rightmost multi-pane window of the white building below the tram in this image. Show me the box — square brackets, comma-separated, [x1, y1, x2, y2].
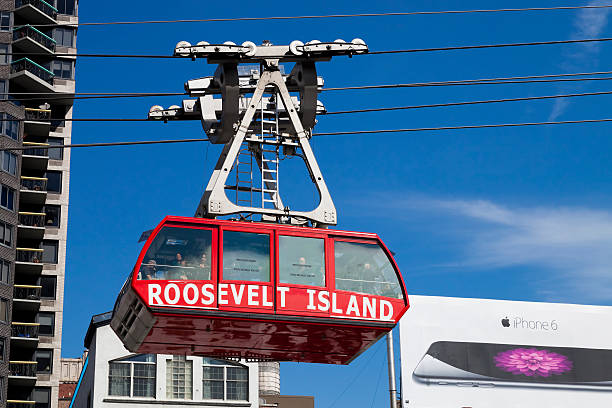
[202, 357, 249, 401]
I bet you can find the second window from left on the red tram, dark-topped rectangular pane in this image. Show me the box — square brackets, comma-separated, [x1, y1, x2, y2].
[223, 231, 270, 282]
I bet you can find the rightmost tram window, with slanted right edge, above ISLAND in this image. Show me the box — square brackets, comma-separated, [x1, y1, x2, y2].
[334, 241, 403, 299]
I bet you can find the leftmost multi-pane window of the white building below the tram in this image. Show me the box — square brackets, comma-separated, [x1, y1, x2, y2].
[108, 354, 156, 398]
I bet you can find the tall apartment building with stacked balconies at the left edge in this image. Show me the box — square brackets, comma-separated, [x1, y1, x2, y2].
[0, 0, 78, 408]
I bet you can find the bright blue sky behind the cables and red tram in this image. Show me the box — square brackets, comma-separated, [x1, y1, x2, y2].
[62, 0, 612, 407]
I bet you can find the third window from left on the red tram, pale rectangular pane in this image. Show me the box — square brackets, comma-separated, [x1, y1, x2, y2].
[278, 235, 325, 286]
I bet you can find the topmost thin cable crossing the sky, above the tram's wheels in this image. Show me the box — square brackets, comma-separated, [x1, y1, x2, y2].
[23, 5, 612, 27]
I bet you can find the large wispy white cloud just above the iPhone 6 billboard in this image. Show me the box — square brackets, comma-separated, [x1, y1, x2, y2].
[388, 197, 612, 302]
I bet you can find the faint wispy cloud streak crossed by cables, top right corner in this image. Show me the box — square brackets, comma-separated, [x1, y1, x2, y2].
[549, 0, 610, 120]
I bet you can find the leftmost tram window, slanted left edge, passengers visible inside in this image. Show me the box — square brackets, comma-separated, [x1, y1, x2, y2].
[138, 227, 212, 280]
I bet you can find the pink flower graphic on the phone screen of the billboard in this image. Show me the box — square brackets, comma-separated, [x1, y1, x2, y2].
[494, 348, 573, 377]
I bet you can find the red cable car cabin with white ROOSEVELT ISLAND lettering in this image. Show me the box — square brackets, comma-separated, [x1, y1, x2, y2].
[111, 216, 409, 364]
